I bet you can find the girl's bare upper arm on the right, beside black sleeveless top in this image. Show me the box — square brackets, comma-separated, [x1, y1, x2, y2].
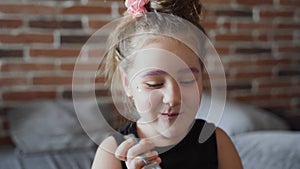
[216, 128, 243, 169]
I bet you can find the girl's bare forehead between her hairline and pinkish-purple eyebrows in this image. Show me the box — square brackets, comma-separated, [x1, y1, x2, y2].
[132, 38, 200, 72]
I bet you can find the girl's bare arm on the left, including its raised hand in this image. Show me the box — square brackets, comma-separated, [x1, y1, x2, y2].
[92, 137, 161, 169]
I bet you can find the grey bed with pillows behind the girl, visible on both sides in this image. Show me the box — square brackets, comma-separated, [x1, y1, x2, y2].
[0, 95, 300, 169]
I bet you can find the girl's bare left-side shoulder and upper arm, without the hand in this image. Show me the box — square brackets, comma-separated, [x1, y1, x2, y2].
[92, 136, 122, 169]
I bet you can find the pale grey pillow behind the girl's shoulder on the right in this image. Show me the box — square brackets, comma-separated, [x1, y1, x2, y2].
[196, 93, 289, 136]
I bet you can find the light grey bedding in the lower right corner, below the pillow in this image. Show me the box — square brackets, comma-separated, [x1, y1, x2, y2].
[232, 131, 300, 169]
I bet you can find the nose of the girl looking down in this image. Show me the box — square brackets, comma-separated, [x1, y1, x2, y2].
[163, 80, 181, 107]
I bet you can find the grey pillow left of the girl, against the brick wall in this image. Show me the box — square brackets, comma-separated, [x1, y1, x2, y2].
[8, 101, 94, 153]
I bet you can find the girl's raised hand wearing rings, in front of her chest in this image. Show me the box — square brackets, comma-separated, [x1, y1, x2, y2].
[115, 139, 161, 169]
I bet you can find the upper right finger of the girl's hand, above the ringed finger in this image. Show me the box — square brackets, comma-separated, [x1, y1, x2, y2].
[127, 139, 155, 158]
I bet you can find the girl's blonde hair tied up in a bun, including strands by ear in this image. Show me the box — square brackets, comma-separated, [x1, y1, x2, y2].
[99, 0, 204, 124]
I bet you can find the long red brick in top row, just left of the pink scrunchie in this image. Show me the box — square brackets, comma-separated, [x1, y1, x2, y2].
[61, 5, 111, 14]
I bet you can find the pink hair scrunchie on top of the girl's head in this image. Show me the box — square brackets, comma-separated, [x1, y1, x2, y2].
[125, 0, 149, 18]
